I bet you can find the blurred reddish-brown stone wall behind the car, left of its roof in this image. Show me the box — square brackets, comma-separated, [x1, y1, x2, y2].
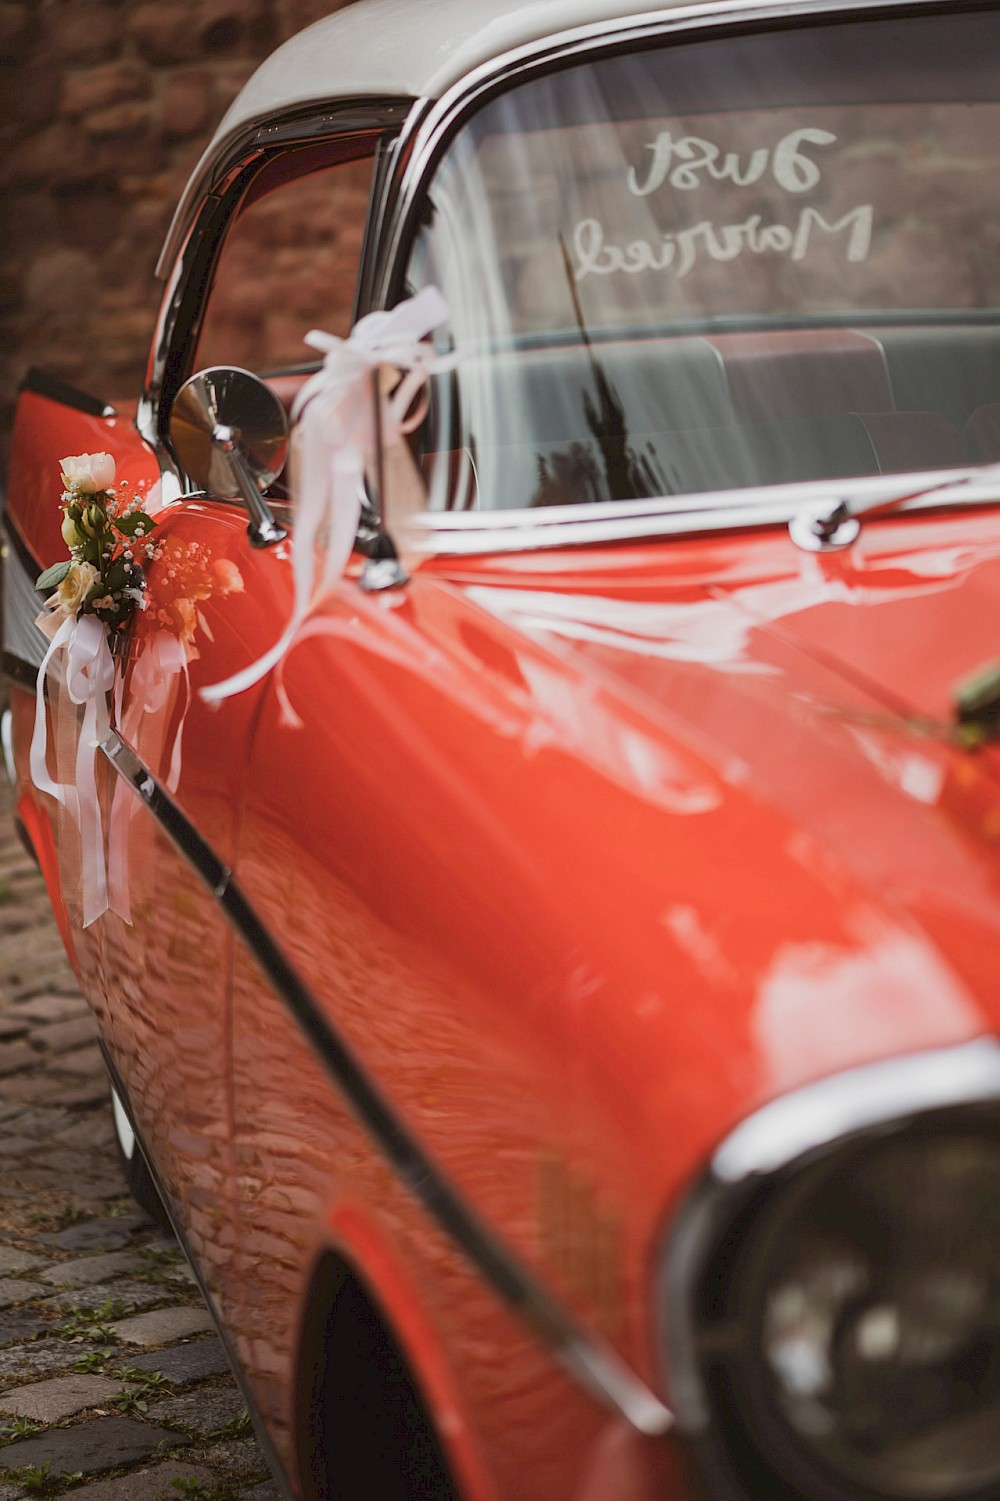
[0, 0, 358, 468]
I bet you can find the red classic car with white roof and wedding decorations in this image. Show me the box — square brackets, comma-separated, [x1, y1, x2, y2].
[3, 0, 1000, 1501]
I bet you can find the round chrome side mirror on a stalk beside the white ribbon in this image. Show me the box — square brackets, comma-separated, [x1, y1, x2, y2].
[168, 366, 288, 548]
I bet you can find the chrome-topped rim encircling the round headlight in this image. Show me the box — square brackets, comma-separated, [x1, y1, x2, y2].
[661, 1039, 1000, 1501]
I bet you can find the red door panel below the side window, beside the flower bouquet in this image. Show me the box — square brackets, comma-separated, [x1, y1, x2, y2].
[99, 501, 279, 1301]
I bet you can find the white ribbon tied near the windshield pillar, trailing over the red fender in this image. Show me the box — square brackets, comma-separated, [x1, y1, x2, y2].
[198, 287, 455, 702]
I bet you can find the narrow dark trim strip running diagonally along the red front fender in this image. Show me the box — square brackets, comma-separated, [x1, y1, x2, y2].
[101, 731, 673, 1435]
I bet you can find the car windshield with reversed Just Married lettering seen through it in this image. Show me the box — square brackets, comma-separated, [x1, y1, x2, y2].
[407, 6, 1000, 510]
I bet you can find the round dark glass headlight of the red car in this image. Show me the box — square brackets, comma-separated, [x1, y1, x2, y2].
[695, 1112, 1000, 1501]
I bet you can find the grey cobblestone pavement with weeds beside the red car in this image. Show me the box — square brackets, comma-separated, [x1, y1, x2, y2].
[0, 770, 278, 1501]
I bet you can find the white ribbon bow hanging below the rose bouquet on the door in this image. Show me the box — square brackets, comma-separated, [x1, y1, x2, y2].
[29, 615, 114, 928]
